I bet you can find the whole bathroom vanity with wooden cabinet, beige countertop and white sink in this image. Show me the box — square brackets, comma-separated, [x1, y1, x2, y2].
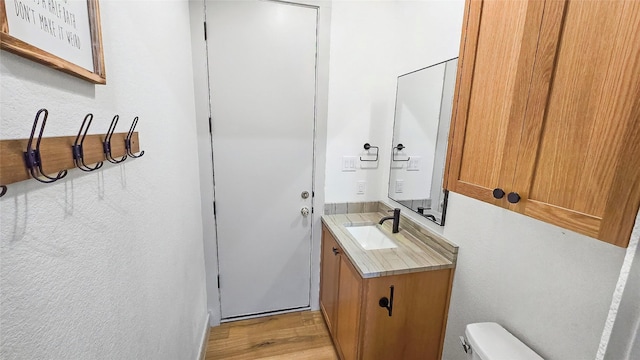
[320, 205, 458, 360]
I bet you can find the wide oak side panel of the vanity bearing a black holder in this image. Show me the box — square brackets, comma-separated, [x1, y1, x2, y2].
[362, 269, 452, 360]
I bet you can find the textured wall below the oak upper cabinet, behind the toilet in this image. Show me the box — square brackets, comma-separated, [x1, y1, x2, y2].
[443, 193, 625, 360]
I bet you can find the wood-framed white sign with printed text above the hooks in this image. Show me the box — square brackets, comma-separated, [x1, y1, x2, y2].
[0, 0, 107, 84]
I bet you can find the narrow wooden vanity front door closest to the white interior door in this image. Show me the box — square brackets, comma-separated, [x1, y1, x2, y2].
[320, 225, 341, 333]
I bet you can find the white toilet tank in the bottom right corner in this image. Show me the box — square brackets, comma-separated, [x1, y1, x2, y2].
[460, 322, 544, 360]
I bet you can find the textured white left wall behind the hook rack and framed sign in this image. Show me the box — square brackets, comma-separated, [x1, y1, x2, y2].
[0, 0, 206, 360]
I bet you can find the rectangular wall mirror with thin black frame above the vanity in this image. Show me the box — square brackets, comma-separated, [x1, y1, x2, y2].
[389, 58, 458, 225]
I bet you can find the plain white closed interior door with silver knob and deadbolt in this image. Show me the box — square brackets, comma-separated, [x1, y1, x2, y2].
[207, 1, 317, 319]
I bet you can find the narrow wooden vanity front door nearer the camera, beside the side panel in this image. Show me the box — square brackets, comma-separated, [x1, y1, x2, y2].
[336, 255, 362, 360]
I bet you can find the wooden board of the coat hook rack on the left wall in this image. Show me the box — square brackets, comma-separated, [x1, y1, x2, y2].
[0, 109, 140, 187]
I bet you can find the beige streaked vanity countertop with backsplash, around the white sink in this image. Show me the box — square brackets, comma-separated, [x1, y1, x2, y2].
[322, 212, 458, 278]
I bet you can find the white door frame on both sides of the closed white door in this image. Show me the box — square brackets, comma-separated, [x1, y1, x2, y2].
[189, 0, 331, 326]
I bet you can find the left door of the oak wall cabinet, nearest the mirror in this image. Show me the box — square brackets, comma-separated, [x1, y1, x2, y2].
[445, 0, 544, 206]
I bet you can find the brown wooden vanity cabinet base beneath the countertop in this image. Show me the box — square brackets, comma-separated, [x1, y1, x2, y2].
[320, 225, 453, 360]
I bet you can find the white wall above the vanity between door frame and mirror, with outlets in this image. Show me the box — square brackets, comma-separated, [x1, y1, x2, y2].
[326, 0, 464, 202]
